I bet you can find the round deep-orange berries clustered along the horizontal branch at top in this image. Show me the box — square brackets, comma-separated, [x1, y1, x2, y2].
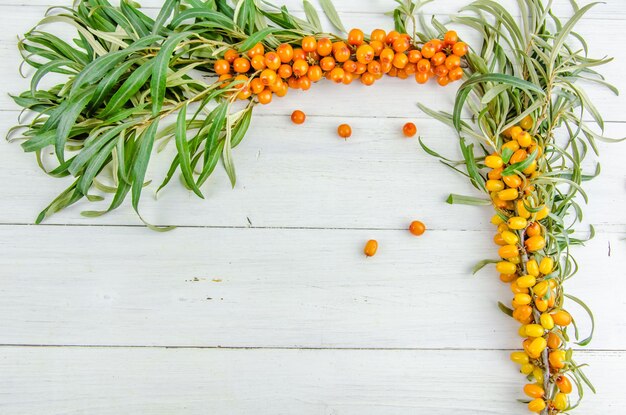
[213, 29, 468, 104]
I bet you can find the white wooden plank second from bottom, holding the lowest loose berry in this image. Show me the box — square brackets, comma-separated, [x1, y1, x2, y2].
[0, 226, 626, 349]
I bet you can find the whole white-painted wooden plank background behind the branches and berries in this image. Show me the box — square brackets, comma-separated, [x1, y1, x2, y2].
[0, 0, 626, 415]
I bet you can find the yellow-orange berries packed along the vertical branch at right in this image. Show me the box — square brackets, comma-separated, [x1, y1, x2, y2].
[485, 117, 572, 414]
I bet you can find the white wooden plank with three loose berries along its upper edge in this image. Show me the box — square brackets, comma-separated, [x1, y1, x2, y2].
[0, 111, 626, 231]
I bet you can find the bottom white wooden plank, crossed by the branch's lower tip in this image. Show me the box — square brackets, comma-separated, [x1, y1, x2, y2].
[0, 347, 626, 415]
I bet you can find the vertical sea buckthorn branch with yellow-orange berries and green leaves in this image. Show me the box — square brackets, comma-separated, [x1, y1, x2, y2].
[422, 0, 615, 415]
